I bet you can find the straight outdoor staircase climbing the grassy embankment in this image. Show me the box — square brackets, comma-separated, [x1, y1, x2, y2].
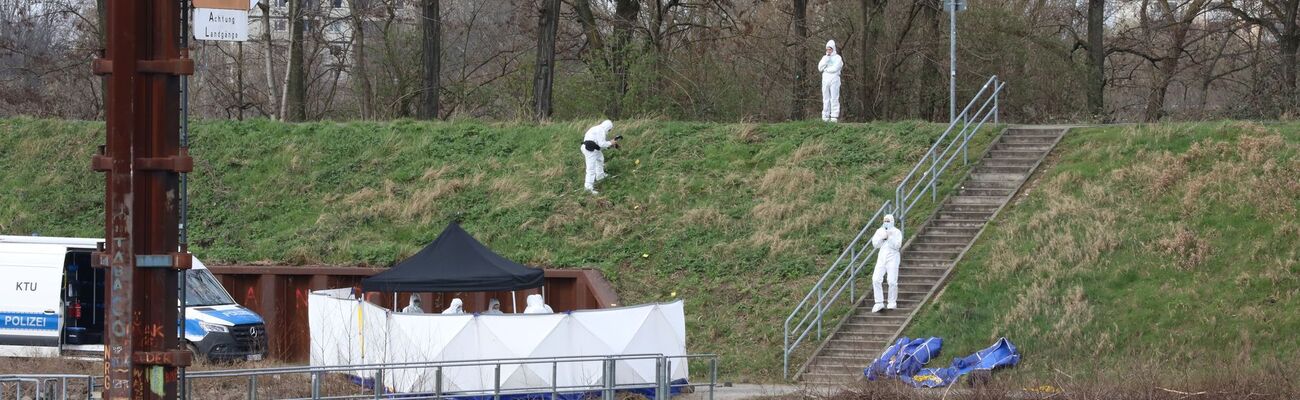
[796, 127, 1066, 384]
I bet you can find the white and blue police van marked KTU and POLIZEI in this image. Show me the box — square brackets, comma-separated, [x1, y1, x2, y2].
[0, 235, 267, 361]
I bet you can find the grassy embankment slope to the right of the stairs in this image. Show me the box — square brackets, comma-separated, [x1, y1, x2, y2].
[906, 122, 1300, 382]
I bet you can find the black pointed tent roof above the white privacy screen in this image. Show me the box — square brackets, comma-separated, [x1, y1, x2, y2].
[361, 222, 543, 292]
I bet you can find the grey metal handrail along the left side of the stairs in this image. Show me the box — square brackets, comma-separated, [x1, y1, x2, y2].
[781, 75, 1006, 379]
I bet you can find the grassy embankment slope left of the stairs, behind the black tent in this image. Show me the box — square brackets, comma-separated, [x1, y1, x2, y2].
[0, 118, 989, 379]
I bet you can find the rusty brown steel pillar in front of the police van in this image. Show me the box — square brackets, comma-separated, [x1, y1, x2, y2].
[91, 0, 194, 399]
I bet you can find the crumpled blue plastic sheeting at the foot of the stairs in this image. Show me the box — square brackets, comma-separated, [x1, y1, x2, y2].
[862, 338, 1021, 387]
